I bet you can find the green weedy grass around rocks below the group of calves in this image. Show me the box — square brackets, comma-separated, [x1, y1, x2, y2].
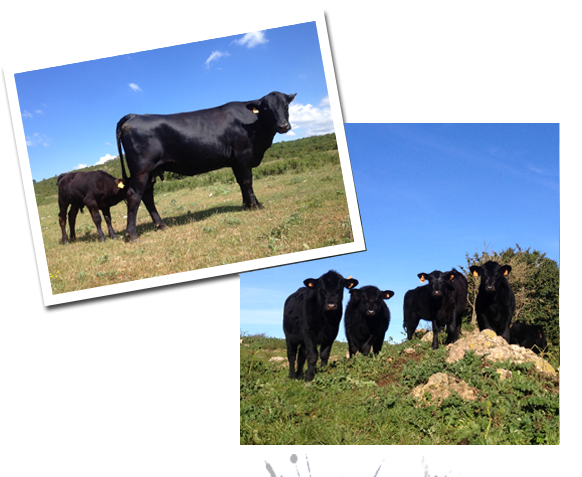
[240, 326, 559, 445]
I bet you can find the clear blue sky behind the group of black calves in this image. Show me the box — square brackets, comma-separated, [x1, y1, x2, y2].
[240, 123, 559, 342]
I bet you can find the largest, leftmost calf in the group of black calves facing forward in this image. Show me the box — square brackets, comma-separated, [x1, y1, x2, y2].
[283, 270, 358, 381]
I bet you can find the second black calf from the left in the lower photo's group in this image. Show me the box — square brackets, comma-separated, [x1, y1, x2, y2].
[344, 286, 394, 357]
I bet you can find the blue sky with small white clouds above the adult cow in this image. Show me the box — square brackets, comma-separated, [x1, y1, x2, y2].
[15, 22, 333, 181]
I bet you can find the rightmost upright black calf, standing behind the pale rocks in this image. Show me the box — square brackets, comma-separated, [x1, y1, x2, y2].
[469, 260, 515, 343]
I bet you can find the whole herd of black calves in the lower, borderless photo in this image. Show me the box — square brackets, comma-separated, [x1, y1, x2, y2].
[283, 261, 547, 381]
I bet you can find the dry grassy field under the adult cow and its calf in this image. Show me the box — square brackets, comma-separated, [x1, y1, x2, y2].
[36, 135, 353, 294]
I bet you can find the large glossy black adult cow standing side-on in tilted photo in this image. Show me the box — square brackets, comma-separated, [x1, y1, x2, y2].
[117, 92, 295, 240]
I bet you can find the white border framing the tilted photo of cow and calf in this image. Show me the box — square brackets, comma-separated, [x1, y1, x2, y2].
[3, 9, 365, 305]
